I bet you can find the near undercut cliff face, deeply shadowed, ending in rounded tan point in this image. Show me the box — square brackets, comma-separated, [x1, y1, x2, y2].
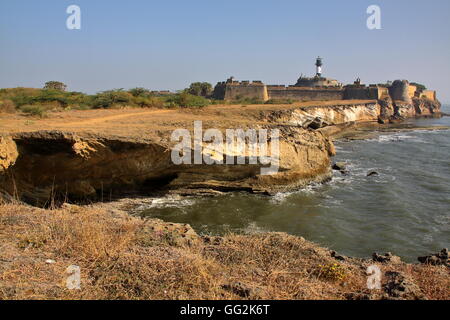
[0, 127, 334, 205]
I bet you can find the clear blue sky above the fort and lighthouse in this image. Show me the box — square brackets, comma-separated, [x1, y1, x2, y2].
[0, 0, 450, 102]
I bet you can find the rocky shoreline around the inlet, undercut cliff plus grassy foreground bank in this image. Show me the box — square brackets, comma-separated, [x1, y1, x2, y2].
[0, 102, 450, 300]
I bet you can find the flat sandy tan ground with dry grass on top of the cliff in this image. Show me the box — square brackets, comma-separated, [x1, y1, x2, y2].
[0, 100, 372, 138]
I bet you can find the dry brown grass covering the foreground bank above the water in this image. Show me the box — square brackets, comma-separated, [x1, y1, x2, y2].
[0, 204, 450, 299]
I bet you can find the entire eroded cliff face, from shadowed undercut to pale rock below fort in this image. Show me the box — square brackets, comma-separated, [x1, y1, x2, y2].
[0, 99, 440, 205]
